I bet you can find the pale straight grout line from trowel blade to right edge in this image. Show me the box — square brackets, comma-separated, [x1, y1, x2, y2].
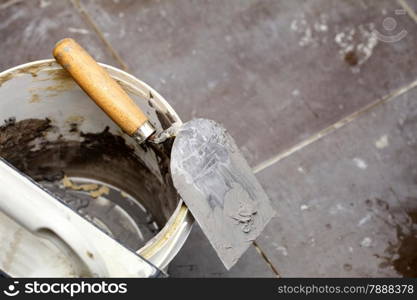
[252, 80, 417, 174]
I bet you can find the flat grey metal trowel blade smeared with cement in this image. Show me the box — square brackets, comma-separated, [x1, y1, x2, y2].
[171, 119, 275, 269]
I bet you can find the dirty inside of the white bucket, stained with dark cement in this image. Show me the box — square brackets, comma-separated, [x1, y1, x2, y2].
[0, 61, 180, 250]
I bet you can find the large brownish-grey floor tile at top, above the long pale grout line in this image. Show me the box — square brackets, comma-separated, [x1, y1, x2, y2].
[83, 0, 417, 165]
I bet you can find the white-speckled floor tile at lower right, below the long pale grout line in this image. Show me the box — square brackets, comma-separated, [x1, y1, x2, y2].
[258, 88, 417, 277]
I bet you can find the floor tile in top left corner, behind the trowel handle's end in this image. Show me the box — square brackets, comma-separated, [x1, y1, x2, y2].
[0, 0, 117, 72]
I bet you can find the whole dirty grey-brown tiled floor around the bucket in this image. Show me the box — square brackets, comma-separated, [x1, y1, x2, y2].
[0, 0, 417, 277]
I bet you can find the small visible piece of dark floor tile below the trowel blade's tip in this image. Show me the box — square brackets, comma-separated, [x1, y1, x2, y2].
[168, 224, 275, 277]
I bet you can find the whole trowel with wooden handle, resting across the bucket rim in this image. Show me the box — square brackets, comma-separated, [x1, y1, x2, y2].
[53, 38, 275, 269]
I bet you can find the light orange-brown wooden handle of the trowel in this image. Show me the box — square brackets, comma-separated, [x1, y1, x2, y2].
[53, 38, 148, 135]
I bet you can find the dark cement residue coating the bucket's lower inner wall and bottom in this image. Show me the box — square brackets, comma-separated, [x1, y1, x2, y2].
[0, 119, 179, 250]
